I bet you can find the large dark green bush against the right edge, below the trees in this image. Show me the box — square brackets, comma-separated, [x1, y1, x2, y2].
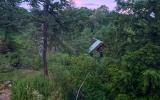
[122, 43, 160, 97]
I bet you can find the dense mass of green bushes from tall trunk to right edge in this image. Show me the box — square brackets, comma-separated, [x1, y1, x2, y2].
[46, 43, 160, 100]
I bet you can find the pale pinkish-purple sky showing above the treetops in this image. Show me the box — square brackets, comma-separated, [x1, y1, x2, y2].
[21, 0, 116, 10]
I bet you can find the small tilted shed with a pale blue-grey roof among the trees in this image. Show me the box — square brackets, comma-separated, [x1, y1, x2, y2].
[88, 38, 105, 57]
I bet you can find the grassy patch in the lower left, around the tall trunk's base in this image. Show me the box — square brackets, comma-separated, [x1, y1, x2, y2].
[0, 69, 62, 100]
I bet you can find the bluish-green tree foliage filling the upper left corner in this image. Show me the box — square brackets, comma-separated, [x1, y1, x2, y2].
[0, 0, 28, 43]
